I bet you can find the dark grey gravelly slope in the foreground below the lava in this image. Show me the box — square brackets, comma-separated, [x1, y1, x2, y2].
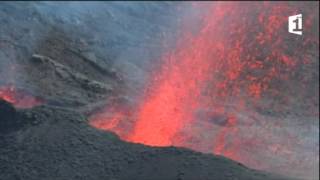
[0, 101, 287, 180]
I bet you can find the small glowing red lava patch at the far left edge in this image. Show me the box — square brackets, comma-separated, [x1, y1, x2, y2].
[0, 86, 43, 108]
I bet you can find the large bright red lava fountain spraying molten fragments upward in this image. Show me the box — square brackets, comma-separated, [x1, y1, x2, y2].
[91, 2, 319, 176]
